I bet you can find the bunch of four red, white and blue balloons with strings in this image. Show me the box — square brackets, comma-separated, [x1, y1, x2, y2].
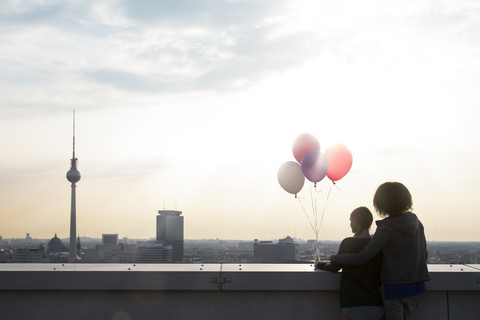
[277, 133, 353, 261]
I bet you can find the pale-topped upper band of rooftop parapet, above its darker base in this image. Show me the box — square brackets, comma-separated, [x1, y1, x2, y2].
[0, 264, 480, 291]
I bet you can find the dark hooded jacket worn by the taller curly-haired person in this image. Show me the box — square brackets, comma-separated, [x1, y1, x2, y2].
[335, 212, 430, 284]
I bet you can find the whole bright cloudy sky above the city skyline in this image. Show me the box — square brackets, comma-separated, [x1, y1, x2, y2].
[0, 0, 480, 241]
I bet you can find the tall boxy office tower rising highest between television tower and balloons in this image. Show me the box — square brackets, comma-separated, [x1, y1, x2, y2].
[157, 210, 183, 262]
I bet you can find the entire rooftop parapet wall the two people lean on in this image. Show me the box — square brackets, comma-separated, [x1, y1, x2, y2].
[0, 264, 480, 320]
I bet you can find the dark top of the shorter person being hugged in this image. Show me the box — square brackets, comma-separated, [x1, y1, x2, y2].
[318, 237, 382, 308]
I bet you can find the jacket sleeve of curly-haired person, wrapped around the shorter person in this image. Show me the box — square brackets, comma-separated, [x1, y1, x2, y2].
[335, 227, 388, 265]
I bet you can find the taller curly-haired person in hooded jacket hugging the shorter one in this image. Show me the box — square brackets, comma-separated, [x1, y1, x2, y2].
[331, 182, 430, 320]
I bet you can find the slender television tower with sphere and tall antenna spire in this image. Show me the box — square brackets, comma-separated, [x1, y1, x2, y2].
[67, 109, 80, 262]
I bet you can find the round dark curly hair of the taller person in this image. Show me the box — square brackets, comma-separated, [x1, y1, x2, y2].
[373, 182, 413, 218]
